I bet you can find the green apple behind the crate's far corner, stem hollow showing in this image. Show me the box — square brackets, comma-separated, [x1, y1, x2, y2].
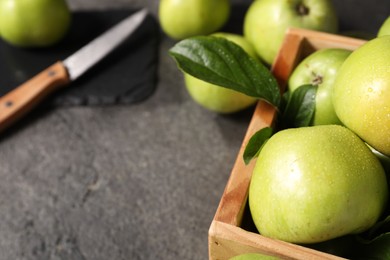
[244, 0, 338, 64]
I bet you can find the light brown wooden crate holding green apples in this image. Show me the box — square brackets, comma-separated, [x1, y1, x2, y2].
[209, 29, 365, 260]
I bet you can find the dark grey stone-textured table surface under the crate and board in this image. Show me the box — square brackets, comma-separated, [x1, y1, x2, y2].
[0, 0, 389, 260]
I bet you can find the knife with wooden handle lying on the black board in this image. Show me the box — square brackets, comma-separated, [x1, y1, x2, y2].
[0, 9, 148, 132]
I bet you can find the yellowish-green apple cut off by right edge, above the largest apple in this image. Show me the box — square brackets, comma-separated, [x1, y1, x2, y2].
[332, 35, 390, 156]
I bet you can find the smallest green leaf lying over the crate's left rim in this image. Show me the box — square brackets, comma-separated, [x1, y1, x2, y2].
[243, 127, 273, 164]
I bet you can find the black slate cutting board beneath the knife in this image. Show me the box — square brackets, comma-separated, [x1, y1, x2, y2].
[0, 10, 160, 106]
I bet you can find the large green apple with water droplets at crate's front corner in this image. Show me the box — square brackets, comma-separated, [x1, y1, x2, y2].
[249, 125, 388, 244]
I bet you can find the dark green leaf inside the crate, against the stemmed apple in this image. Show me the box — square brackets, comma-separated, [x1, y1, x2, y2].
[282, 84, 317, 128]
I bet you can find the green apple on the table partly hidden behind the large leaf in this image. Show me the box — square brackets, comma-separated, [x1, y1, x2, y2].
[184, 33, 260, 114]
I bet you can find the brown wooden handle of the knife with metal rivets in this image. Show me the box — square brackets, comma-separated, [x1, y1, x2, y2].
[0, 61, 70, 132]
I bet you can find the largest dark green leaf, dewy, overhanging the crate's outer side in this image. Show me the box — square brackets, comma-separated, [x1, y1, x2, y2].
[169, 36, 281, 107]
